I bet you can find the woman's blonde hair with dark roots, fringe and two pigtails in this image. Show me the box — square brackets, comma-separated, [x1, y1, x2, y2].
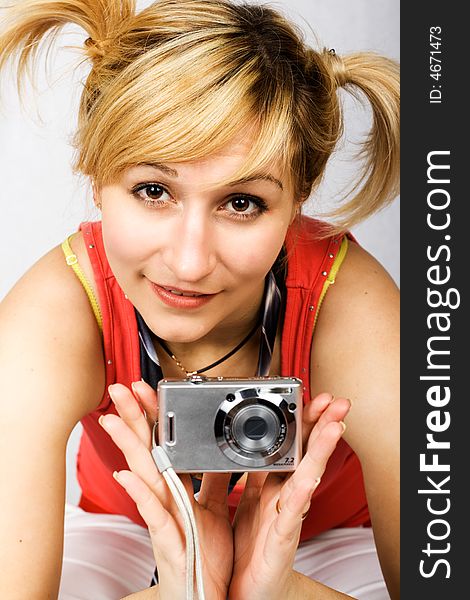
[0, 0, 399, 229]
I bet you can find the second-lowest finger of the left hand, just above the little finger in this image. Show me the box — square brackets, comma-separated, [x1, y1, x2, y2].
[99, 414, 175, 513]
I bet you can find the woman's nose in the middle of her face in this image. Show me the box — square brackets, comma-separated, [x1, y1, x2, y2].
[165, 206, 217, 285]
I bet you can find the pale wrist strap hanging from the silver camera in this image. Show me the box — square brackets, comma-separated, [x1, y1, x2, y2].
[152, 446, 205, 600]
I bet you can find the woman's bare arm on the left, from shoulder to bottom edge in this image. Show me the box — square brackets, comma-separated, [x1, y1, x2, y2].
[0, 248, 104, 600]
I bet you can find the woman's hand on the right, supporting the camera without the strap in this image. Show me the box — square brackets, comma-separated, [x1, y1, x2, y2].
[229, 394, 350, 600]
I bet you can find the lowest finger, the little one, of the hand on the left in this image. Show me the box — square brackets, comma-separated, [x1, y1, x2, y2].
[113, 471, 185, 559]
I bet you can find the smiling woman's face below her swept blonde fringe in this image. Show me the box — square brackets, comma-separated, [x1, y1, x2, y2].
[98, 137, 295, 342]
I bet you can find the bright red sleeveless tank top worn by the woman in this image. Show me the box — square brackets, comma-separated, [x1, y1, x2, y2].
[77, 217, 370, 540]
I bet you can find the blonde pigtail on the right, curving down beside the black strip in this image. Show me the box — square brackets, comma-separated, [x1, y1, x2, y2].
[323, 50, 400, 229]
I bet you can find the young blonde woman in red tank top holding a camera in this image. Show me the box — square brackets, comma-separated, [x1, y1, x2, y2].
[0, 0, 399, 600]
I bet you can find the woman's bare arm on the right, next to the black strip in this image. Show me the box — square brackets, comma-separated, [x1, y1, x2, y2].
[311, 244, 399, 599]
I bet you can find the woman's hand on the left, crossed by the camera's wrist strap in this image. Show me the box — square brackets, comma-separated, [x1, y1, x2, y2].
[100, 382, 233, 600]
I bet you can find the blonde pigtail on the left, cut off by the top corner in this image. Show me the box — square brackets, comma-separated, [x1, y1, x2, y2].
[0, 0, 135, 96]
